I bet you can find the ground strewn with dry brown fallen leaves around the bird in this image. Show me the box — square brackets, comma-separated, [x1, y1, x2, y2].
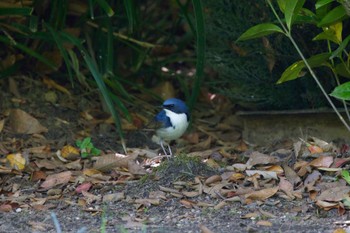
[0, 77, 350, 232]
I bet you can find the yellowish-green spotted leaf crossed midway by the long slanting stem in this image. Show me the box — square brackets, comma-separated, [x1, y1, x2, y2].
[277, 53, 330, 84]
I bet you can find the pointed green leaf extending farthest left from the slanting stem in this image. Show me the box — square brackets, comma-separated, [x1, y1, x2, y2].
[237, 23, 284, 41]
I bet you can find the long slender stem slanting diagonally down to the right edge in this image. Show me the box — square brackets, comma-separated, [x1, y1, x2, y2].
[267, 0, 350, 131]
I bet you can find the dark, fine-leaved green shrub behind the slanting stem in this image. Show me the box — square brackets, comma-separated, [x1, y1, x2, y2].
[204, 0, 349, 109]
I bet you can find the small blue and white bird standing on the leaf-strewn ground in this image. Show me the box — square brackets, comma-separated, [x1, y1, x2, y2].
[155, 98, 190, 156]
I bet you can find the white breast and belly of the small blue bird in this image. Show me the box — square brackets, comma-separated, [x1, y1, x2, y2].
[156, 109, 188, 140]
